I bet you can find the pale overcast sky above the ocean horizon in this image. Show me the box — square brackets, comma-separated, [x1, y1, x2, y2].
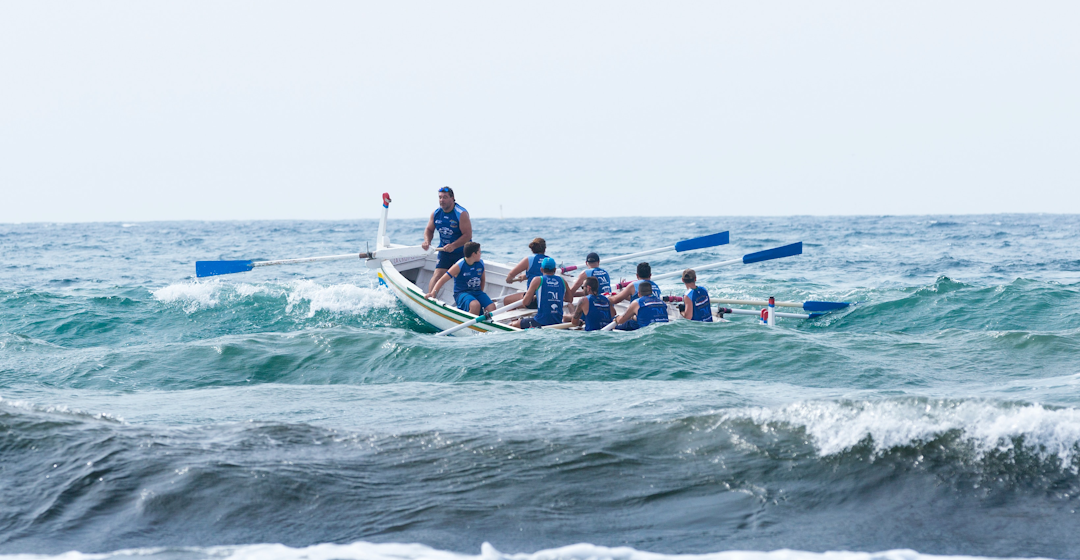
[0, 0, 1080, 222]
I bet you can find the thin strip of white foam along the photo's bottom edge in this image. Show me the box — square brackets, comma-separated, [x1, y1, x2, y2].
[0, 543, 1049, 560]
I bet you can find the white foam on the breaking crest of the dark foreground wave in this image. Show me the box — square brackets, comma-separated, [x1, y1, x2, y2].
[724, 399, 1080, 464]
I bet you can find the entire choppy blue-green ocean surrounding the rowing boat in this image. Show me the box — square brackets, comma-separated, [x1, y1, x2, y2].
[0, 215, 1080, 560]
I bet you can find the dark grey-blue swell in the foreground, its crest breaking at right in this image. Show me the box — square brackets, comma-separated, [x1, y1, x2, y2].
[0, 399, 1080, 558]
